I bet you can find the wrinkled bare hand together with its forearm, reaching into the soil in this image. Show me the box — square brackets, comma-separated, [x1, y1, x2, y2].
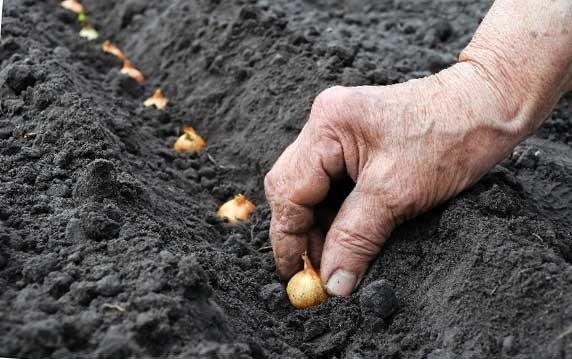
[265, 0, 572, 295]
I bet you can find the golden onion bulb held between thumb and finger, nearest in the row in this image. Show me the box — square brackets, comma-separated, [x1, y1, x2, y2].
[286, 253, 328, 309]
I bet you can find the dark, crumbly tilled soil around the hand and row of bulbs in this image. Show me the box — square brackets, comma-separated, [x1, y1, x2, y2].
[0, 0, 572, 359]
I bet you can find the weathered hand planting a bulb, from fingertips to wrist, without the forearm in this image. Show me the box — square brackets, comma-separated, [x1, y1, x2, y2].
[265, 62, 529, 296]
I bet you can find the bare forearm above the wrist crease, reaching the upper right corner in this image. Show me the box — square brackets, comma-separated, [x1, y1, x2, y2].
[459, 0, 572, 137]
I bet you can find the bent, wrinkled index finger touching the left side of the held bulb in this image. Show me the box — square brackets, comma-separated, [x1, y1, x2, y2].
[265, 126, 345, 279]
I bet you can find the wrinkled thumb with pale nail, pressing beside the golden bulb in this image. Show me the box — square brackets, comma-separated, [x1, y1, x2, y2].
[320, 190, 395, 296]
